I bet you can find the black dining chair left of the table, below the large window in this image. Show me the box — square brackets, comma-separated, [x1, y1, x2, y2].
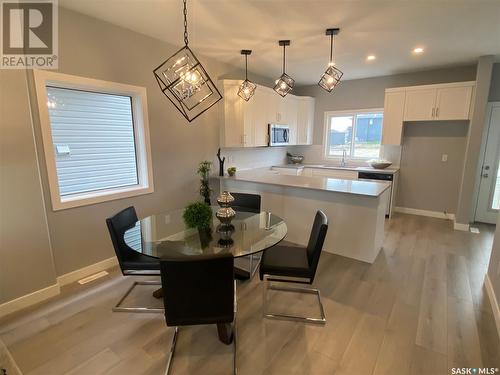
[106, 207, 163, 313]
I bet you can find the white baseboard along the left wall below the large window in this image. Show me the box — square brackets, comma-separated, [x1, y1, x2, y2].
[0, 257, 118, 318]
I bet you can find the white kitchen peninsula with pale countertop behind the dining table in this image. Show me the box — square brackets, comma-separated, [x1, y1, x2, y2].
[219, 168, 390, 263]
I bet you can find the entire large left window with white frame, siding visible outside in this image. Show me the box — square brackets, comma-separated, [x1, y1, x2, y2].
[35, 71, 153, 210]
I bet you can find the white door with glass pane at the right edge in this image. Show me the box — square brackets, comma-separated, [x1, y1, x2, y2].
[475, 102, 500, 224]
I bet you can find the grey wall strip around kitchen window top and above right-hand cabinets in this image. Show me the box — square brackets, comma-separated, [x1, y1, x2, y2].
[295, 66, 476, 144]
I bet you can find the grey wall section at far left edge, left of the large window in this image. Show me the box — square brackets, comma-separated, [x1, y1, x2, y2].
[0, 70, 56, 304]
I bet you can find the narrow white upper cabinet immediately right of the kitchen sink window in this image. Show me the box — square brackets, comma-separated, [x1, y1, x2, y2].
[382, 89, 406, 145]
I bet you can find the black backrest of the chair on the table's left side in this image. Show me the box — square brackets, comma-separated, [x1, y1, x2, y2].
[106, 207, 137, 272]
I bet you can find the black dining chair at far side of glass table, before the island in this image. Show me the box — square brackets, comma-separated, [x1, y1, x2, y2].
[231, 193, 261, 280]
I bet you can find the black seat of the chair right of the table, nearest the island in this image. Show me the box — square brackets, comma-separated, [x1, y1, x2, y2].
[259, 245, 311, 279]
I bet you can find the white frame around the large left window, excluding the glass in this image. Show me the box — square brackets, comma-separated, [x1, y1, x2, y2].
[33, 69, 154, 211]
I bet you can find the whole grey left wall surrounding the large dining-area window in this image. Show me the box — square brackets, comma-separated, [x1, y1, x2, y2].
[0, 8, 278, 303]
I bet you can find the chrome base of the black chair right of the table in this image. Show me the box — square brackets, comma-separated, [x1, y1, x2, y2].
[263, 275, 326, 324]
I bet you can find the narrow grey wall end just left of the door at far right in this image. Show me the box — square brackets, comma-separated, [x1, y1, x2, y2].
[456, 56, 493, 224]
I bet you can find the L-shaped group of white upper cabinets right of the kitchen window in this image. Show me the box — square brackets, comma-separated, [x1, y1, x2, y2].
[382, 81, 476, 145]
